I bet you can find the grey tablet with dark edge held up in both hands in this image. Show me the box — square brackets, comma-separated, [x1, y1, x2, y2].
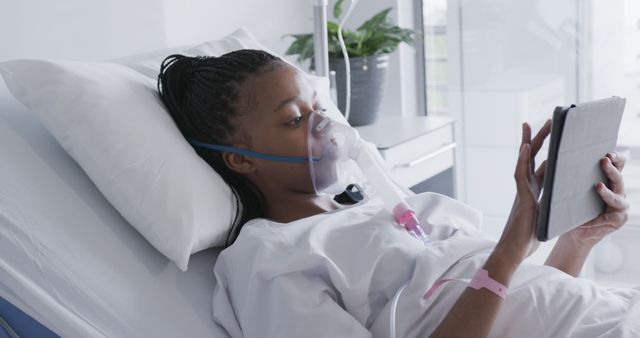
[536, 97, 626, 241]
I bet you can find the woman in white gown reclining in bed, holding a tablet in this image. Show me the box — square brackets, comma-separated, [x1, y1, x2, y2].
[158, 50, 640, 337]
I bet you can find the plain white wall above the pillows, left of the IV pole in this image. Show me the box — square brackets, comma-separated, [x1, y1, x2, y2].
[0, 0, 313, 60]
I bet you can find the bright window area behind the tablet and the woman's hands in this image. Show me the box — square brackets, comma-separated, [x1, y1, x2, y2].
[416, 0, 640, 284]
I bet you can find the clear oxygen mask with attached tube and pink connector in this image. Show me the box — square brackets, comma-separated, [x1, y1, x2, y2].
[307, 111, 431, 245]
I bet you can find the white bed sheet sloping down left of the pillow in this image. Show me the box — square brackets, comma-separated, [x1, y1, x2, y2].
[0, 81, 226, 337]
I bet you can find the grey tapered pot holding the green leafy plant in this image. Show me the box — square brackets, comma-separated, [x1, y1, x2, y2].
[329, 54, 389, 126]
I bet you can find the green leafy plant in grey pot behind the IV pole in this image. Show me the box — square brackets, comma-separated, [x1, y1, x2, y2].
[286, 0, 416, 126]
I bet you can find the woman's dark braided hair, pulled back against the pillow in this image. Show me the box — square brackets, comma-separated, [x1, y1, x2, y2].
[158, 49, 285, 246]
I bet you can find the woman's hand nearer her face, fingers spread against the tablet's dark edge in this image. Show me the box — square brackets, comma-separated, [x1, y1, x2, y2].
[495, 120, 551, 264]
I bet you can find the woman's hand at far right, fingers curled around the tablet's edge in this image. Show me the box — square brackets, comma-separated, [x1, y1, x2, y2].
[563, 153, 629, 251]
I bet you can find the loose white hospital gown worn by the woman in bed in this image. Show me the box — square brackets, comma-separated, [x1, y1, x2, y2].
[213, 193, 640, 338]
